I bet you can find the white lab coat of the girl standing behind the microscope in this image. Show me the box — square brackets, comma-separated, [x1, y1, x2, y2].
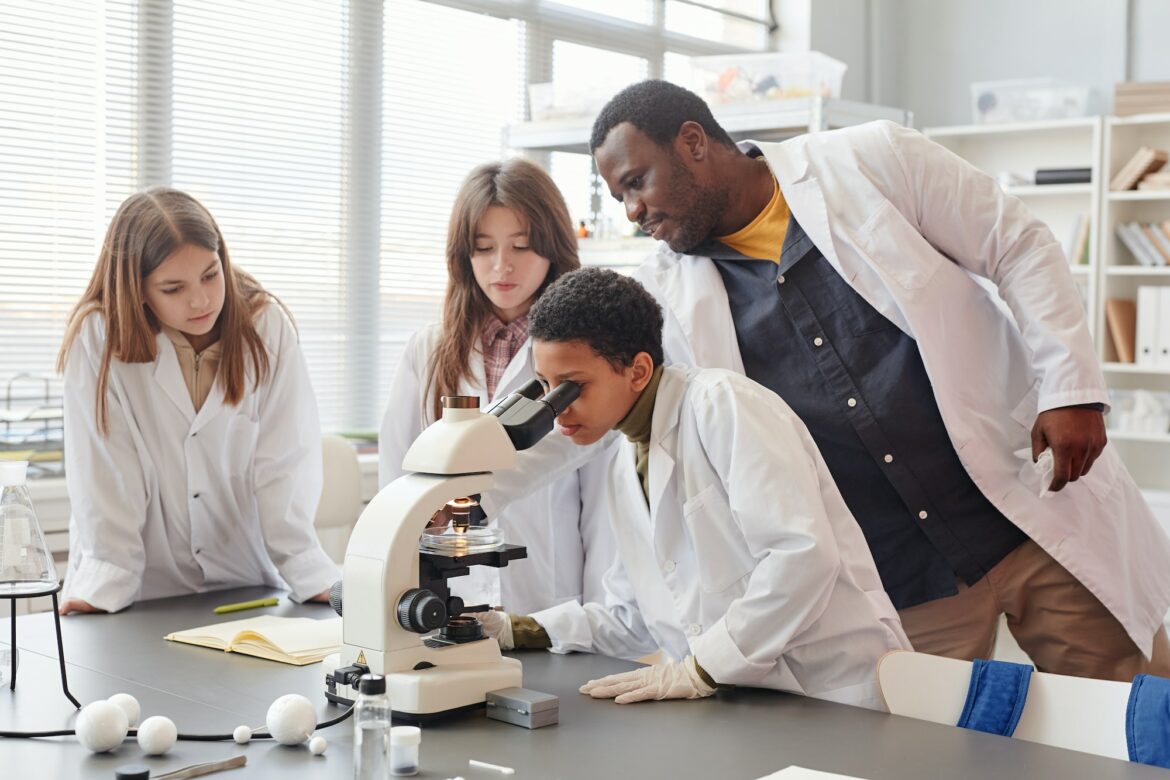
[378, 324, 614, 613]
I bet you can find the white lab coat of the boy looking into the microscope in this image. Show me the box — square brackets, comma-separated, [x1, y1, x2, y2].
[534, 365, 910, 710]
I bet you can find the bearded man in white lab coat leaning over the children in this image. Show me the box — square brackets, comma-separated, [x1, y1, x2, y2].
[591, 81, 1170, 679]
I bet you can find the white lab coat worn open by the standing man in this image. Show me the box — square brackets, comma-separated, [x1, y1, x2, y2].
[636, 122, 1170, 656]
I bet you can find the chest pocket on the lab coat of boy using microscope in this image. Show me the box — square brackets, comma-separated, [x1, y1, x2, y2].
[682, 484, 755, 593]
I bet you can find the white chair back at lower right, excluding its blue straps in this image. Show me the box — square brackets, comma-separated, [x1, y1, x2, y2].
[878, 650, 1129, 761]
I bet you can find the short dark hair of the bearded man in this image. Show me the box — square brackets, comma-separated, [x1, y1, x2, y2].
[589, 78, 735, 154]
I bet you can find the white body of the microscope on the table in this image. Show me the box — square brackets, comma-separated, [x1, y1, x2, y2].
[326, 386, 577, 719]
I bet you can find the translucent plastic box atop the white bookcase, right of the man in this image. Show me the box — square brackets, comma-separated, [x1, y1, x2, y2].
[971, 78, 1089, 123]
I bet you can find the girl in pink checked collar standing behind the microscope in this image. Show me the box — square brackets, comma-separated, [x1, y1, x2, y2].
[378, 158, 614, 614]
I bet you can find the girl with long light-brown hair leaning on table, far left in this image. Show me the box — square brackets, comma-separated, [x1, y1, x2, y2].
[57, 187, 338, 614]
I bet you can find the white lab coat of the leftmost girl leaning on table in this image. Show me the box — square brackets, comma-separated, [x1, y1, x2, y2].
[64, 305, 340, 612]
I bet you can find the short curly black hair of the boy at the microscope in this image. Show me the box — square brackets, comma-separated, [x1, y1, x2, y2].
[528, 268, 662, 370]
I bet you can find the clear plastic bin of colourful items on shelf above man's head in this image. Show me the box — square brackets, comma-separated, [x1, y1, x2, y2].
[690, 51, 848, 105]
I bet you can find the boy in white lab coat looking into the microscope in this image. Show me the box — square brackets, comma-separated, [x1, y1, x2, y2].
[486, 269, 909, 709]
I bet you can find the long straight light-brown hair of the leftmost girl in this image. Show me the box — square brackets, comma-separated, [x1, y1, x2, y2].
[57, 187, 283, 435]
